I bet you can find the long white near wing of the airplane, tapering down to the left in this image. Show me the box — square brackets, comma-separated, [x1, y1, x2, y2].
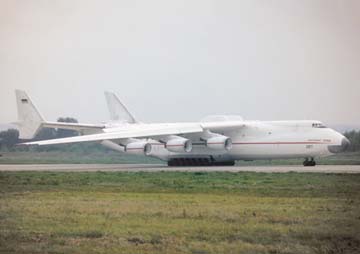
[22, 124, 203, 145]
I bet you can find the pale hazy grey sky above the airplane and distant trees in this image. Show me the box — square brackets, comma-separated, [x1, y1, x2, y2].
[0, 0, 360, 124]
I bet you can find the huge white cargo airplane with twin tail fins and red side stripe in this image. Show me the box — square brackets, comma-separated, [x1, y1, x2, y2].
[16, 90, 350, 166]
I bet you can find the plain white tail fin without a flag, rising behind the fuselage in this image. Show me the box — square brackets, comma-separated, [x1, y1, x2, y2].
[105, 92, 138, 123]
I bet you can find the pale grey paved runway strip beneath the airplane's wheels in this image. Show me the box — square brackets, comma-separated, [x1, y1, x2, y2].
[0, 164, 360, 173]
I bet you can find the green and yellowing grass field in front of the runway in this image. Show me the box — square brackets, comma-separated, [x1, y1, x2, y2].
[0, 172, 360, 254]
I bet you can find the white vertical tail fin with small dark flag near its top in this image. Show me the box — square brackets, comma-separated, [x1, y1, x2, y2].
[15, 90, 44, 139]
